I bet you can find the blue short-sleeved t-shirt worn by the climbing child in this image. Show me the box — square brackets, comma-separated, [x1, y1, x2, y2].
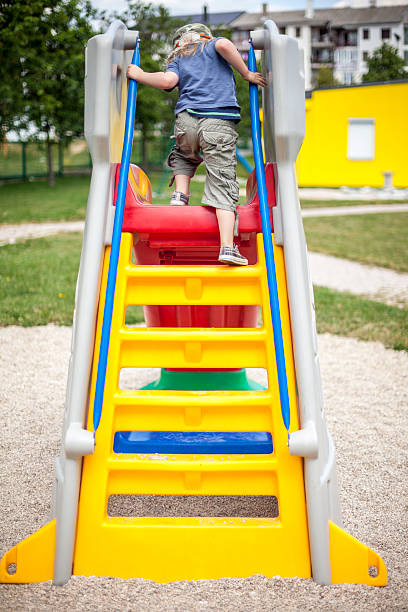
[165, 38, 240, 120]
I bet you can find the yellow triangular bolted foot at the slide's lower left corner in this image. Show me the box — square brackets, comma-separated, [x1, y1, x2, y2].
[0, 519, 56, 583]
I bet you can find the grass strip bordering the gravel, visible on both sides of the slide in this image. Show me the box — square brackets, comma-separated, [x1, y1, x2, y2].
[0, 234, 408, 351]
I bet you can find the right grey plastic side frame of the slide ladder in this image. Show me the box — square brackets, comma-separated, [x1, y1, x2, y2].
[251, 21, 342, 584]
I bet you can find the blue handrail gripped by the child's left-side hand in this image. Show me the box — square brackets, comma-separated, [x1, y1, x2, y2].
[93, 39, 140, 431]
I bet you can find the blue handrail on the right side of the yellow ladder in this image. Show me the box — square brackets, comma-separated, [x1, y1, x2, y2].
[248, 41, 290, 430]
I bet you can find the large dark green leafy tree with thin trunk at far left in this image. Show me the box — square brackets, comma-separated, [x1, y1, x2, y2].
[2, 0, 97, 185]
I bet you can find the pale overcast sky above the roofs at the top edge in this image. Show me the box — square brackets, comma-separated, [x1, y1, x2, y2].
[91, 0, 335, 15]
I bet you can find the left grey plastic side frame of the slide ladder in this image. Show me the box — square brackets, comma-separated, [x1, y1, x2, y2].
[54, 21, 138, 585]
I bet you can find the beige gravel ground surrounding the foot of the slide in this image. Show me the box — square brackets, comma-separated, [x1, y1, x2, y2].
[0, 325, 408, 612]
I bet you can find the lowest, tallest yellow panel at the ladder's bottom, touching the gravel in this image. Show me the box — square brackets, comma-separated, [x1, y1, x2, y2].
[74, 517, 311, 582]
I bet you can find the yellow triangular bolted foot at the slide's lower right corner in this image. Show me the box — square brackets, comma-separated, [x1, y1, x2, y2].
[329, 521, 387, 586]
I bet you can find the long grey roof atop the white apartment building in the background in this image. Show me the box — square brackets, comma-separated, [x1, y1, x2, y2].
[229, 4, 408, 30]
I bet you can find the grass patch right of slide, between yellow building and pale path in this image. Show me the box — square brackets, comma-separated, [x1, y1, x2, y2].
[303, 213, 408, 272]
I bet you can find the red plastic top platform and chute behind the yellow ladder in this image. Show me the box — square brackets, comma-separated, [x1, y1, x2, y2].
[115, 164, 275, 327]
